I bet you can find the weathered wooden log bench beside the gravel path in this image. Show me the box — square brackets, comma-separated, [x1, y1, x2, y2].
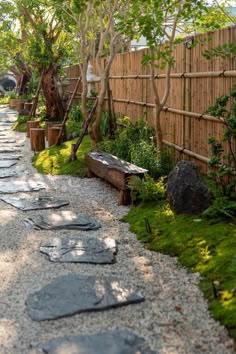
[85, 151, 147, 205]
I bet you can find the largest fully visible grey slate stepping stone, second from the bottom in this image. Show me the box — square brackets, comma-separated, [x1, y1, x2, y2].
[26, 274, 144, 321]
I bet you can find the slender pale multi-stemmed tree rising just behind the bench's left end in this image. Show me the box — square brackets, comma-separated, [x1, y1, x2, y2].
[58, 0, 128, 147]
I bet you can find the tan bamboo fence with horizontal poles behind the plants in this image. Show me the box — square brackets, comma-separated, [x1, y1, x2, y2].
[63, 26, 236, 173]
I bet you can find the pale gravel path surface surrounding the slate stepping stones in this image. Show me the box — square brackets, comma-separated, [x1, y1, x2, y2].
[0, 108, 234, 354]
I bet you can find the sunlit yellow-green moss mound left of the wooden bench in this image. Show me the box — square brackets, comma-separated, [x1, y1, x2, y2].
[33, 136, 91, 177]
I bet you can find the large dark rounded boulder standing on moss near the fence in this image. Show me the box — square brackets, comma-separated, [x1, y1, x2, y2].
[167, 161, 212, 214]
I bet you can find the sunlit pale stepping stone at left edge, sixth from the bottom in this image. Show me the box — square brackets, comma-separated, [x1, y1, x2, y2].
[0, 180, 45, 194]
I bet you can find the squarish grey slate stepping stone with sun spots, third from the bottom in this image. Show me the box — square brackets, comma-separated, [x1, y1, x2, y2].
[40, 237, 117, 264]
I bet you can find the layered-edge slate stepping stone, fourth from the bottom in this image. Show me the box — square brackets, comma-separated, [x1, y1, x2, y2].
[24, 210, 101, 230]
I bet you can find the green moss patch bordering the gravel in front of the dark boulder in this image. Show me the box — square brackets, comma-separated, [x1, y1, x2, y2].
[123, 202, 236, 341]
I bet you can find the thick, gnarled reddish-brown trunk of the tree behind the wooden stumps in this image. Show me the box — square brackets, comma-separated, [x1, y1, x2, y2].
[42, 64, 65, 121]
